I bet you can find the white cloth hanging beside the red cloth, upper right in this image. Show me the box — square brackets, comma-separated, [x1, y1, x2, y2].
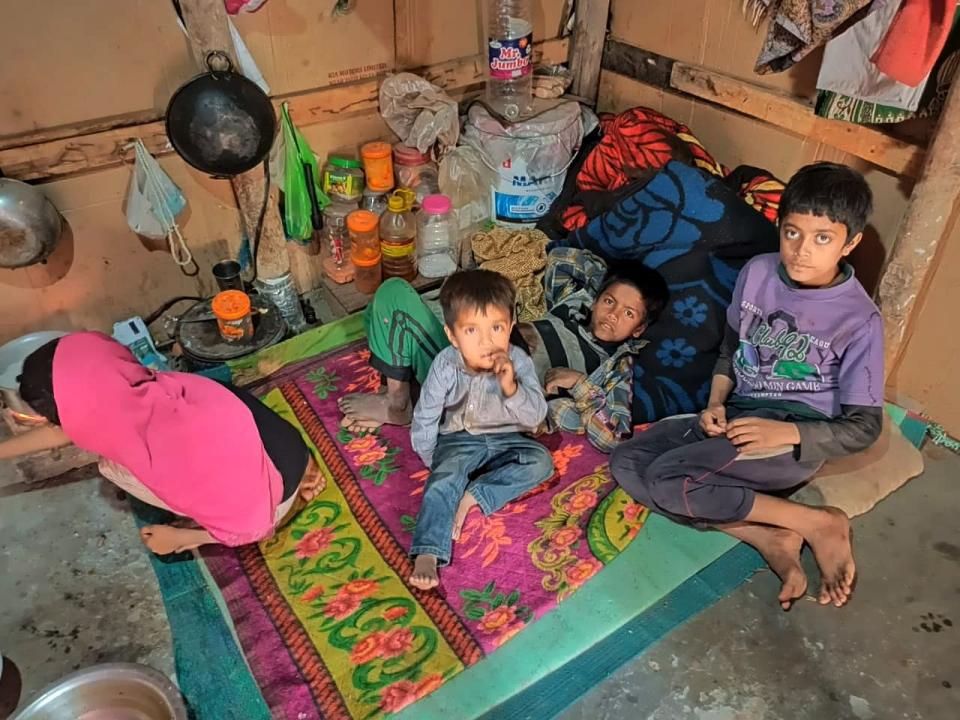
[817, 0, 926, 116]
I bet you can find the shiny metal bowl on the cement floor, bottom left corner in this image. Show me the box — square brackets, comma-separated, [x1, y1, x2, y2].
[13, 663, 187, 720]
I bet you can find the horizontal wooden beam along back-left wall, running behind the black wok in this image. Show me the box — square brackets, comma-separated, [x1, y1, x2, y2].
[0, 39, 569, 180]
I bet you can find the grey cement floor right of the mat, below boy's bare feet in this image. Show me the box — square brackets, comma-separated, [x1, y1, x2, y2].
[559, 447, 960, 720]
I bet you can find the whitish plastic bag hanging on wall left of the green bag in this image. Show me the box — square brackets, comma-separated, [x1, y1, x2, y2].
[127, 139, 193, 268]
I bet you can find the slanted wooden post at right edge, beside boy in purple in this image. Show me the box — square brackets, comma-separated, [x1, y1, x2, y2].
[877, 77, 960, 377]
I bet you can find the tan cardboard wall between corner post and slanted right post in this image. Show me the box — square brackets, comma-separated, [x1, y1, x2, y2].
[599, 0, 912, 290]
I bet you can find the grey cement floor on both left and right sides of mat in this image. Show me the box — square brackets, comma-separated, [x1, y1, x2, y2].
[0, 448, 960, 720]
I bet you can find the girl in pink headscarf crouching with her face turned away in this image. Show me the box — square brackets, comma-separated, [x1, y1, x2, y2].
[0, 332, 322, 554]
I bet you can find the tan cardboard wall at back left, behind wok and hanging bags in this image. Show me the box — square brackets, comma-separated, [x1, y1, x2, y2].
[0, 0, 566, 343]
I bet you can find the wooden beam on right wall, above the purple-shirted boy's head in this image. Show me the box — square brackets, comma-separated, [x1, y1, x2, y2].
[603, 40, 924, 178]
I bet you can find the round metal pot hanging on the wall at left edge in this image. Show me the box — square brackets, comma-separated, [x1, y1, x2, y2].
[0, 178, 63, 268]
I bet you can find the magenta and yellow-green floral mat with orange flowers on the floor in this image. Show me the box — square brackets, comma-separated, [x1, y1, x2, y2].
[203, 342, 647, 720]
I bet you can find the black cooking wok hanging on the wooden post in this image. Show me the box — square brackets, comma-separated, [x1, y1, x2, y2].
[167, 51, 277, 177]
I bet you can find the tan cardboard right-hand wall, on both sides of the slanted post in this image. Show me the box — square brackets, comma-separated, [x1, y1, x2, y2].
[600, 0, 960, 436]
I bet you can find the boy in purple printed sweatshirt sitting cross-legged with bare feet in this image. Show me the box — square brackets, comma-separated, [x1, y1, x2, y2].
[610, 162, 883, 610]
